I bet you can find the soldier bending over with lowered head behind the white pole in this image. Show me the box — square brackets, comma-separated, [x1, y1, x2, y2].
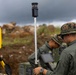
[28, 35, 62, 69]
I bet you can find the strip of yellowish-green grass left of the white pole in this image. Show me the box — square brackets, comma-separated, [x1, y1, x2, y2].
[3, 36, 33, 46]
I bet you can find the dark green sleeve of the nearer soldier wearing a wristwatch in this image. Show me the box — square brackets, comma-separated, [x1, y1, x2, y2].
[46, 52, 70, 75]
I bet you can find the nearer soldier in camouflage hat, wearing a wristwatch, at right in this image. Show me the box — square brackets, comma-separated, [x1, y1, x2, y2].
[34, 22, 76, 75]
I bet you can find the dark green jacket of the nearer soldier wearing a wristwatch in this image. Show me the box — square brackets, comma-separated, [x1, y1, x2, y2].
[46, 40, 76, 75]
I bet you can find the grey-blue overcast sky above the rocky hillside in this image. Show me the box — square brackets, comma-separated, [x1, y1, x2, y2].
[0, 0, 76, 25]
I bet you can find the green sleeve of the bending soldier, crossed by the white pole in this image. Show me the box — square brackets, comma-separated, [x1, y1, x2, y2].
[28, 42, 52, 68]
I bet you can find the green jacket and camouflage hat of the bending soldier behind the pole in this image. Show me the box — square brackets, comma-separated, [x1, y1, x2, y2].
[28, 35, 61, 68]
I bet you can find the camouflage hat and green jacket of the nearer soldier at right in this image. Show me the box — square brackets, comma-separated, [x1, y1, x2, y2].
[46, 22, 76, 75]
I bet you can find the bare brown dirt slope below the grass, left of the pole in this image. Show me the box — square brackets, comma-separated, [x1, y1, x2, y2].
[0, 45, 34, 75]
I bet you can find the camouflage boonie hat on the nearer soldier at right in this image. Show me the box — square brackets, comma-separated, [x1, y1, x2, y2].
[60, 22, 76, 35]
